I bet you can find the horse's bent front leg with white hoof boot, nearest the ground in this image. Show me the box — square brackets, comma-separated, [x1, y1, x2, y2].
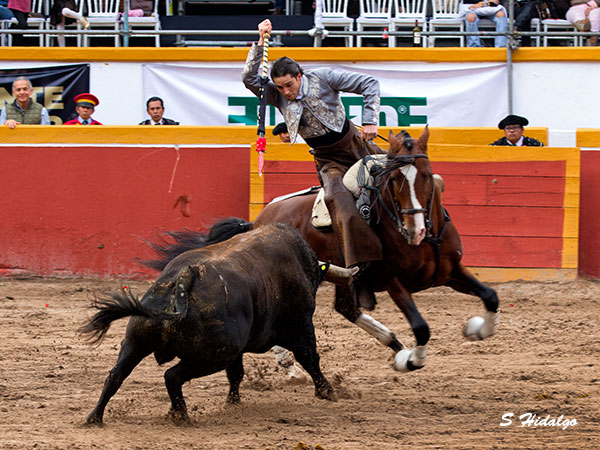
[387, 278, 430, 372]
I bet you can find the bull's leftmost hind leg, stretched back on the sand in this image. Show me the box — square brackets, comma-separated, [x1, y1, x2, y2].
[86, 339, 151, 425]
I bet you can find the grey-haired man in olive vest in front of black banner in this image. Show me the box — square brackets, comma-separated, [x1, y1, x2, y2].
[0, 77, 50, 128]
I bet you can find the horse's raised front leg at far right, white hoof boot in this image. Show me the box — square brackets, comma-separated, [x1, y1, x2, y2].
[446, 264, 500, 341]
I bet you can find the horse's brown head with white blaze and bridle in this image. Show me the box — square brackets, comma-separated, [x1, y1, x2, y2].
[385, 127, 434, 245]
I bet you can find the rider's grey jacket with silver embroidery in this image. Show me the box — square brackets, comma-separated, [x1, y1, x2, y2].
[242, 44, 379, 143]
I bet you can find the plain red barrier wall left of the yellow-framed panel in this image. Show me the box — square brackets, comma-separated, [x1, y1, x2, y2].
[0, 144, 249, 278]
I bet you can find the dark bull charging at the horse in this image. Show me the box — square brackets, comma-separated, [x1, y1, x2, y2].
[80, 219, 336, 424]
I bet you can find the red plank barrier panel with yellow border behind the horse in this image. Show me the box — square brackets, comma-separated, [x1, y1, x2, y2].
[250, 145, 580, 281]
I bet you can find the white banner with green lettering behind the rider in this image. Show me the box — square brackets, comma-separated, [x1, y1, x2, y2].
[142, 62, 508, 127]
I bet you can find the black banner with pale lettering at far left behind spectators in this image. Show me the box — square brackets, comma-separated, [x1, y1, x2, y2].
[0, 64, 90, 125]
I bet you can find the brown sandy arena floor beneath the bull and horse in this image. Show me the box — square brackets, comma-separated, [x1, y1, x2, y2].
[0, 279, 600, 450]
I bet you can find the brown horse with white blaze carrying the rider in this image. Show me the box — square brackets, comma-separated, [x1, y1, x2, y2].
[254, 127, 499, 372]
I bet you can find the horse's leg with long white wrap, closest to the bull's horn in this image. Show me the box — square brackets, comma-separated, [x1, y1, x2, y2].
[335, 286, 404, 353]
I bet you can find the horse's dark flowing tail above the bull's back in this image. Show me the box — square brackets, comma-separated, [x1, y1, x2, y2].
[142, 217, 254, 270]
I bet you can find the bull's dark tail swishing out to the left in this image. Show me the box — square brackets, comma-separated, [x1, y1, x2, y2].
[78, 289, 180, 344]
